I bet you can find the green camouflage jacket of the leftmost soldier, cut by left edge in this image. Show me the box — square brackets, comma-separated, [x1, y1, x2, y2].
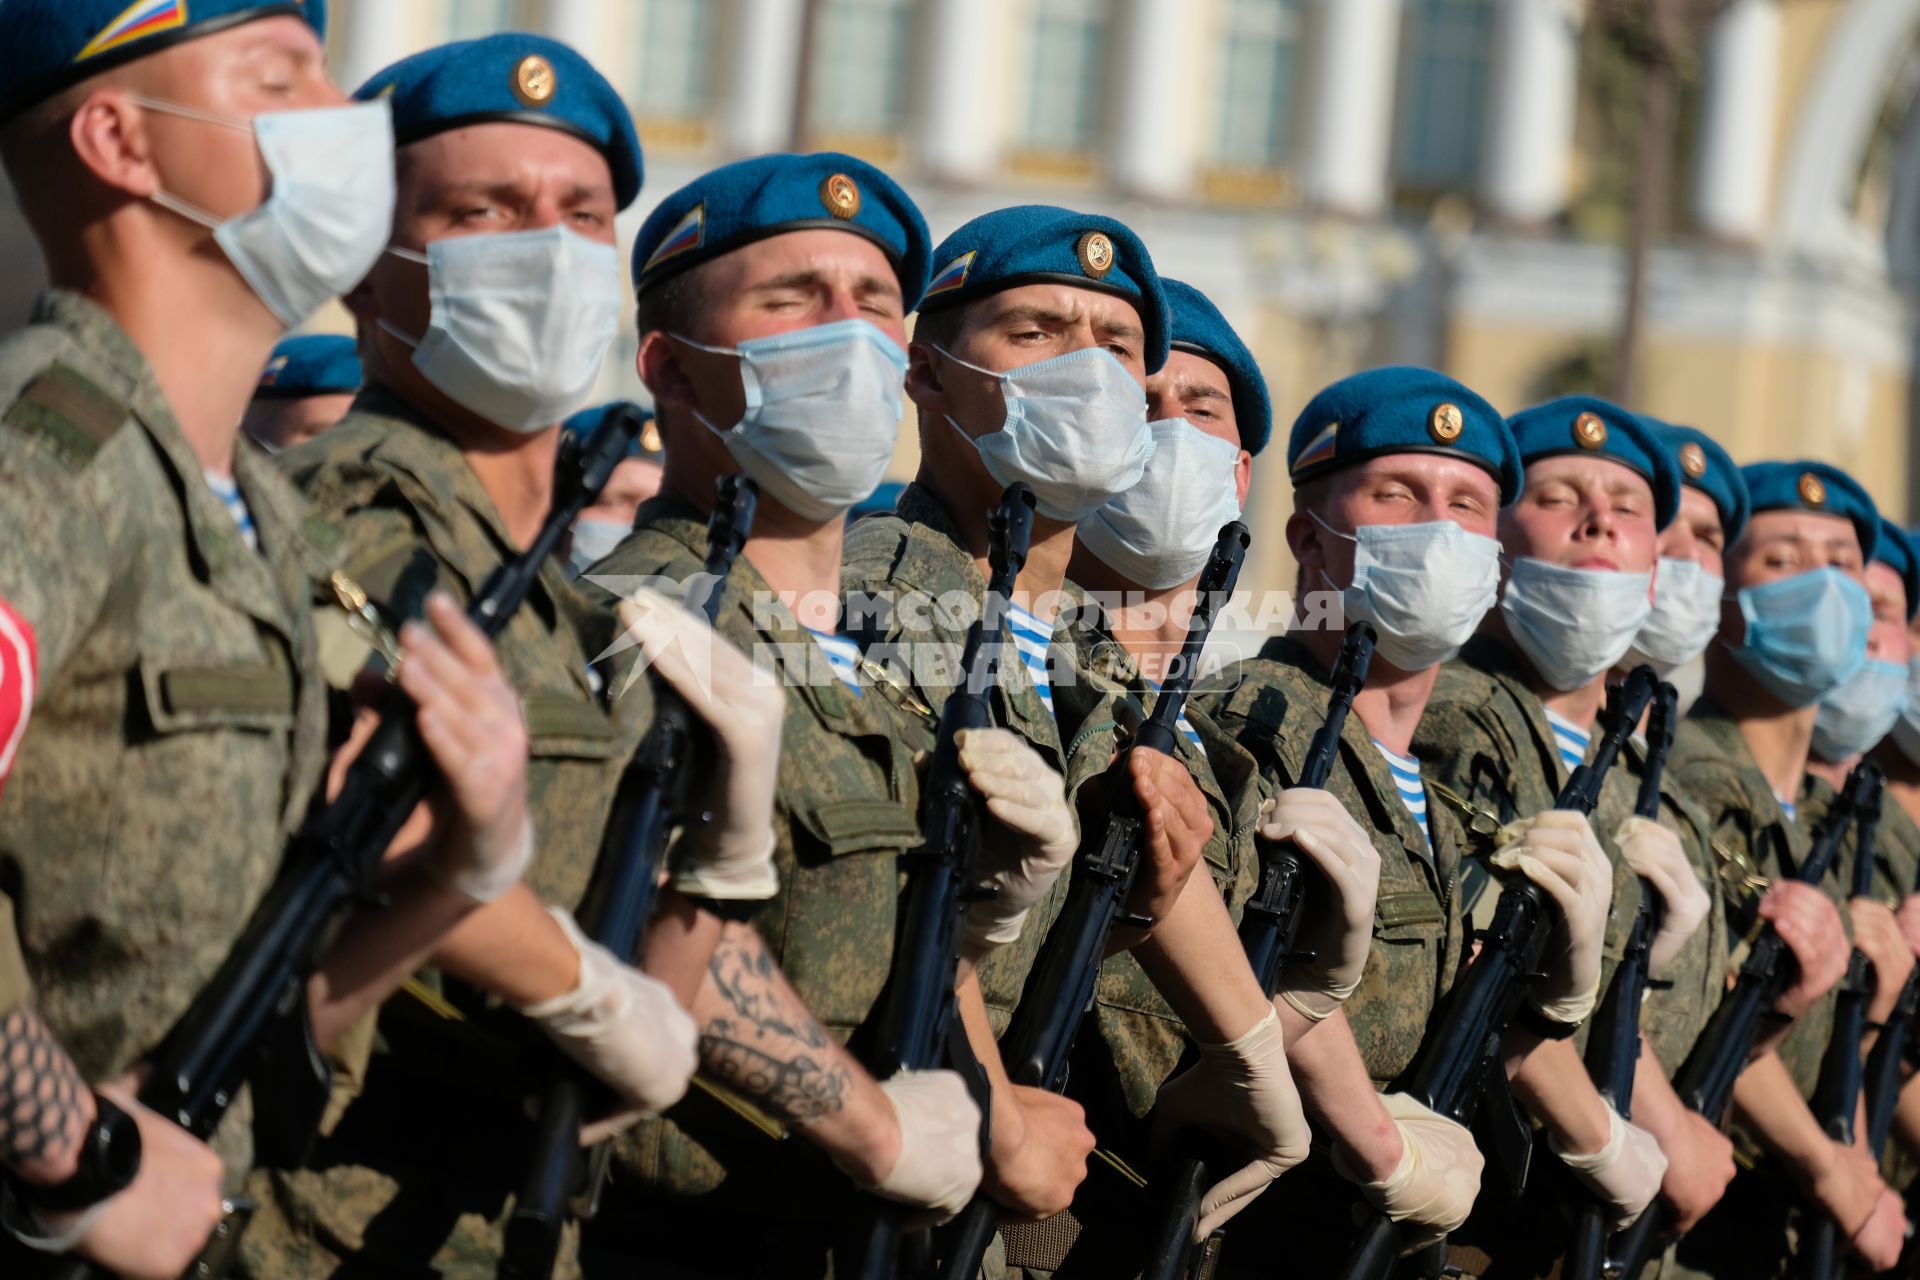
[0, 292, 330, 1090]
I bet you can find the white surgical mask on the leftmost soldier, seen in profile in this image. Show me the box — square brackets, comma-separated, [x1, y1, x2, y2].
[131, 96, 394, 328]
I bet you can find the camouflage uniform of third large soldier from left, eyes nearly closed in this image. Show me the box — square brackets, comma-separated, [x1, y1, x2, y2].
[568, 497, 933, 1276]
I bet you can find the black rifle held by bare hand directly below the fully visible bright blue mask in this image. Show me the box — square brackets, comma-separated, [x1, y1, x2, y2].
[1607, 764, 1885, 1280]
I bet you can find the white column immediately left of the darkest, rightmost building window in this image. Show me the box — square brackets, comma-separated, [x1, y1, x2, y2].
[1302, 0, 1400, 217]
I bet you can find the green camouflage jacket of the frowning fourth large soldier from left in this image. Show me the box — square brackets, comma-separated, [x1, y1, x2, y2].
[841, 484, 1066, 1034]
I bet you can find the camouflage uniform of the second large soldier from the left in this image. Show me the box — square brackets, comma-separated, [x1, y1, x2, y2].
[246, 388, 645, 1278]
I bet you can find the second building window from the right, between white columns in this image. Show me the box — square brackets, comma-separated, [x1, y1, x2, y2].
[1213, 0, 1302, 169]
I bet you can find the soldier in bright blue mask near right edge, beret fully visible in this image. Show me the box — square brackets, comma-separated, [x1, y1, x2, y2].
[1668, 462, 1901, 1276]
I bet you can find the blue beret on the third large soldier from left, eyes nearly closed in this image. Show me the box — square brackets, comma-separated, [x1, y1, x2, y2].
[634, 152, 933, 311]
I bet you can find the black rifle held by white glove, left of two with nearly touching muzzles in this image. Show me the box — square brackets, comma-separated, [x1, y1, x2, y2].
[1340, 666, 1659, 1280]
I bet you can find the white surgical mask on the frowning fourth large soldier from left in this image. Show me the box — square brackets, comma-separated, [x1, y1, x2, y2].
[935, 347, 1154, 524]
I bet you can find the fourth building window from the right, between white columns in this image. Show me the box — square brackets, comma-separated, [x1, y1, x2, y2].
[806, 0, 914, 138]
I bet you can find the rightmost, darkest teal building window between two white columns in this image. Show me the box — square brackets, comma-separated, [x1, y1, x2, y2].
[1396, 0, 1494, 192]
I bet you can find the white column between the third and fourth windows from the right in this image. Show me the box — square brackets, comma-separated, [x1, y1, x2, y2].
[914, 0, 1004, 184]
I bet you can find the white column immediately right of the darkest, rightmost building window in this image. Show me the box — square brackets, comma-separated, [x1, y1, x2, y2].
[1480, 0, 1584, 223]
